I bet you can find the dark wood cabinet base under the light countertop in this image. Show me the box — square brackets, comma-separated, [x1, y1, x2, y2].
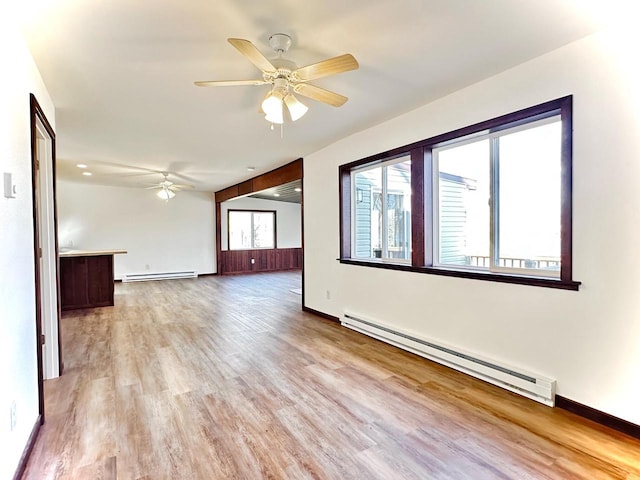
[60, 255, 119, 310]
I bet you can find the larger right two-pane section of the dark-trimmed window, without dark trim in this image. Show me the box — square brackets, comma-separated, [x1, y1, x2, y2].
[433, 115, 562, 277]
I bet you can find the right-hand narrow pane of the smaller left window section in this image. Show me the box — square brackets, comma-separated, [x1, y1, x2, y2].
[385, 160, 411, 260]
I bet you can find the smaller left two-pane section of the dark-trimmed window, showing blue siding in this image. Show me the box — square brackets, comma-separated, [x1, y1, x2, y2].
[351, 156, 411, 262]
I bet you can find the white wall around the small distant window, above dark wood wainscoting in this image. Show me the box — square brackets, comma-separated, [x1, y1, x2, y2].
[220, 197, 302, 250]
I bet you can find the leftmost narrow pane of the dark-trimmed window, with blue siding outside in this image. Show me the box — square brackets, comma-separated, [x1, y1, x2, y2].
[353, 167, 382, 258]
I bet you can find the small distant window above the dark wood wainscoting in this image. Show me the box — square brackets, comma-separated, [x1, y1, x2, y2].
[228, 210, 276, 250]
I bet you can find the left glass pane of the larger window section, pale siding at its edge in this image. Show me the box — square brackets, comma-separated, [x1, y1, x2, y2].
[437, 139, 490, 268]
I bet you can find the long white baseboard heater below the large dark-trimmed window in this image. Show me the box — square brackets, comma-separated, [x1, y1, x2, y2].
[341, 312, 556, 407]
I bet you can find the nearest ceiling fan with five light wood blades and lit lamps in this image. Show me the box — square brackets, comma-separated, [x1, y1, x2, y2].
[194, 33, 358, 124]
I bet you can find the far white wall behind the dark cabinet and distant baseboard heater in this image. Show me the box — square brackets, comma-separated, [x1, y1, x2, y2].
[57, 180, 216, 279]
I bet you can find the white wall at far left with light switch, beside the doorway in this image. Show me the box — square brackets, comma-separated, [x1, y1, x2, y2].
[0, 15, 55, 479]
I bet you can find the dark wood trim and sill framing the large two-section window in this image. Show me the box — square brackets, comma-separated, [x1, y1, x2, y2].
[338, 95, 580, 290]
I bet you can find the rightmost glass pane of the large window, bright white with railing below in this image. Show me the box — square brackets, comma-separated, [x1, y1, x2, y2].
[496, 120, 561, 273]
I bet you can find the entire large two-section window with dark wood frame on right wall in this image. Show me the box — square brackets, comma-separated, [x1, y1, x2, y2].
[340, 97, 580, 290]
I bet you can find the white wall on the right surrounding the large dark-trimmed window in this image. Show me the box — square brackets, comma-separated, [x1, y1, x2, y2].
[304, 30, 640, 424]
